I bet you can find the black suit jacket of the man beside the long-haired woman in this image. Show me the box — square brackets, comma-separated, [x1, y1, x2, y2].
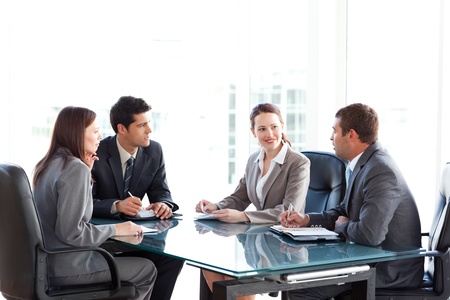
[92, 136, 178, 218]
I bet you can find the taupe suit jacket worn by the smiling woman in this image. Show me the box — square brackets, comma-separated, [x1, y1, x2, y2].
[216, 147, 310, 223]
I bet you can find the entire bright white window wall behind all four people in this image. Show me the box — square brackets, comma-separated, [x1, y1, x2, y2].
[0, 0, 450, 228]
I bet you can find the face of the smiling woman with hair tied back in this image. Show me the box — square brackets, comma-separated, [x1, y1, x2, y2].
[251, 113, 283, 152]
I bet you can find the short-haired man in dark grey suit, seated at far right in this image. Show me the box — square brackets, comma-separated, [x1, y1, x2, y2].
[281, 103, 424, 300]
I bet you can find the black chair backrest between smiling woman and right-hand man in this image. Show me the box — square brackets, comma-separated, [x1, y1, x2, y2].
[302, 151, 346, 213]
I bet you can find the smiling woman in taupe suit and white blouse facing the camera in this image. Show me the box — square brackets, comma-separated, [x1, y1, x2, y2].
[195, 103, 310, 299]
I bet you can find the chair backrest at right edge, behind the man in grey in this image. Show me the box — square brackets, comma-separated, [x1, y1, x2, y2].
[427, 163, 450, 291]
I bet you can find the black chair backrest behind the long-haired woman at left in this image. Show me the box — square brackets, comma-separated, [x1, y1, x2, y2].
[0, 163, 43, 299]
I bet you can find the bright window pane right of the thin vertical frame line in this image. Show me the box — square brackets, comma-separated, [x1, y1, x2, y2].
[347, 0, 450, 231]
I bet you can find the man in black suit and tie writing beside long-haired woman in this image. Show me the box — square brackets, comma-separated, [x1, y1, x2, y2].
[92, 96, 184, 300]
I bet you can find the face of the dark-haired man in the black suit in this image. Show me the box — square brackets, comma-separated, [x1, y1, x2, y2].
[123, 113, 152, 148]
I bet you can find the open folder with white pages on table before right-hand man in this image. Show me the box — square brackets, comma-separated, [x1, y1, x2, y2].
[270, 225, 341, 242]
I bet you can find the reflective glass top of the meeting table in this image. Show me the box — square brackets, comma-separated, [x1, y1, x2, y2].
[92, 215, 420, 278]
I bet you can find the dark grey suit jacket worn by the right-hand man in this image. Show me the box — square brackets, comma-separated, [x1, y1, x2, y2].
[309, 142, 424, 288]
